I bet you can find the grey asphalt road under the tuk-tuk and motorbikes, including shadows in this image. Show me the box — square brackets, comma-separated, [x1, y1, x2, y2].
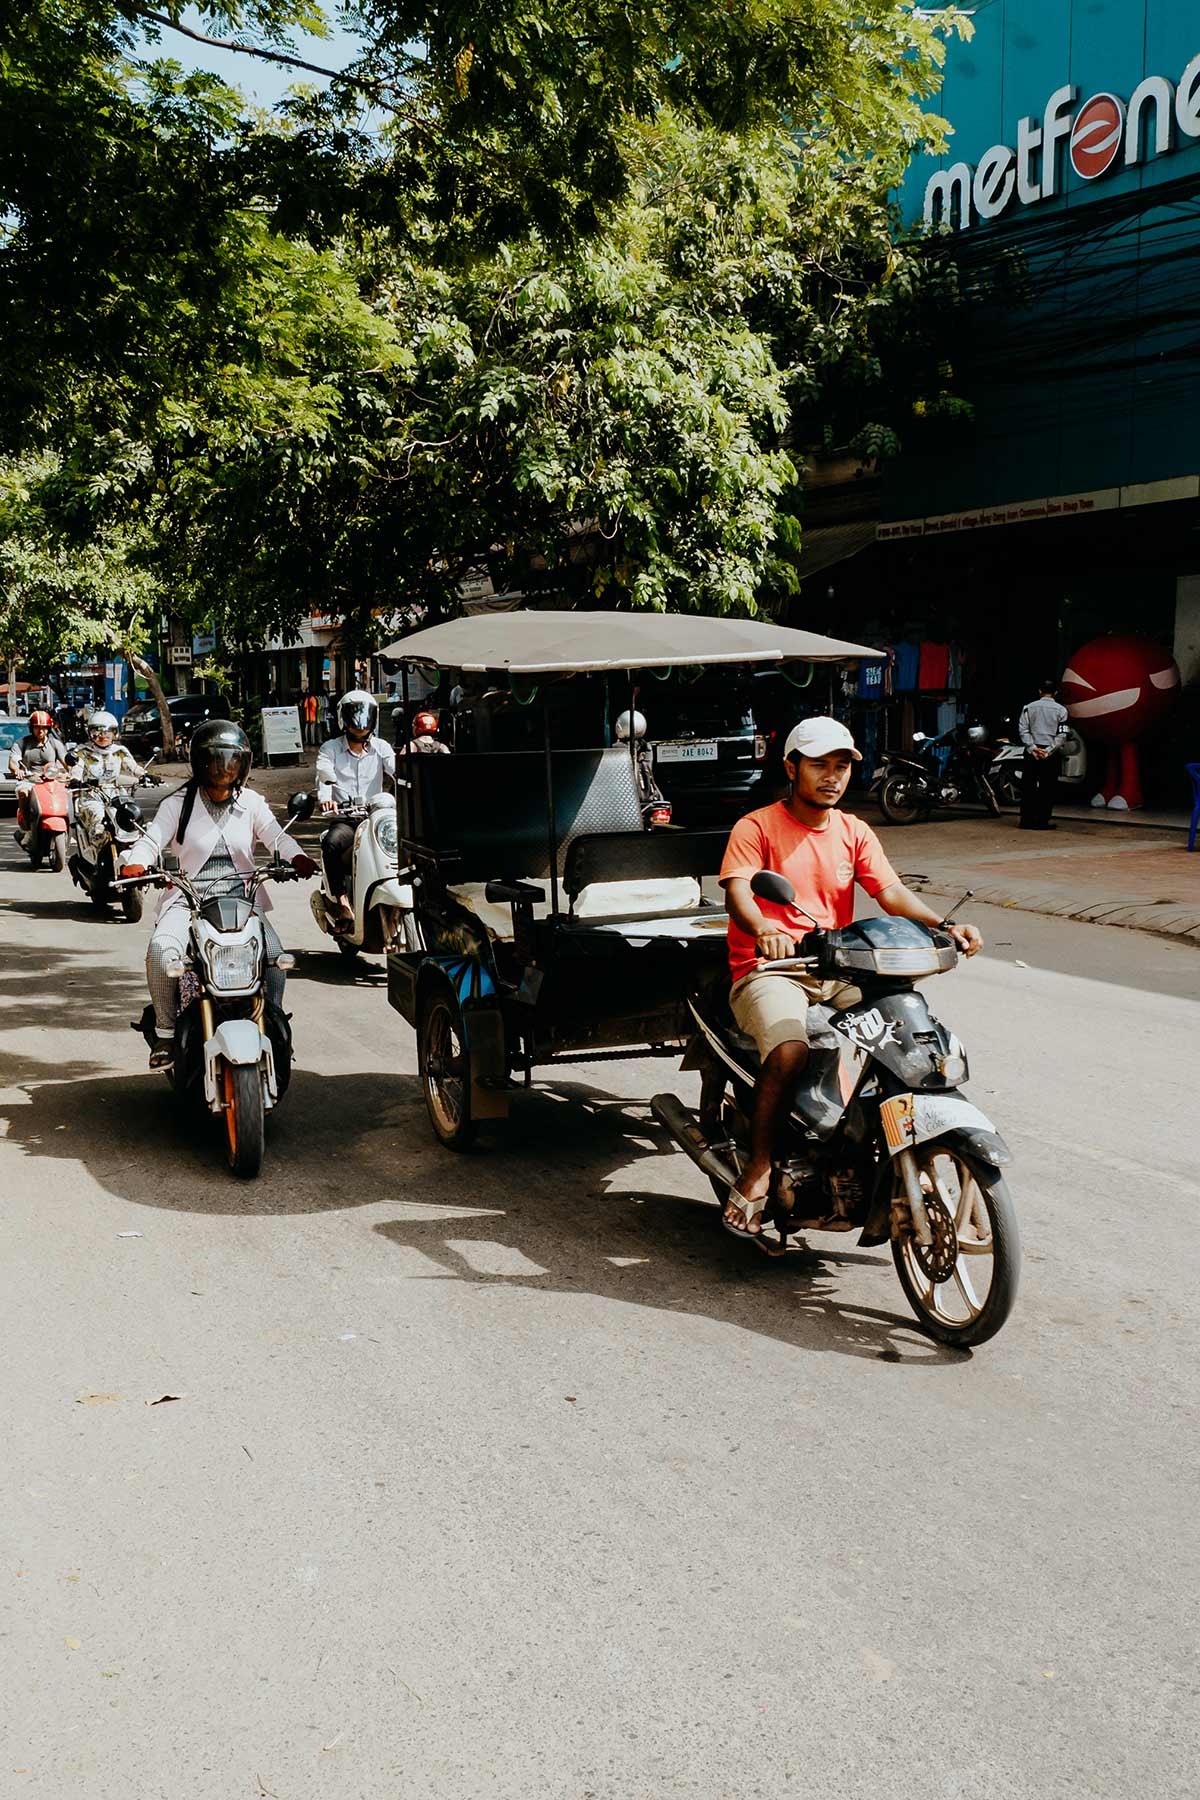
[0, 826, 1200, 1800]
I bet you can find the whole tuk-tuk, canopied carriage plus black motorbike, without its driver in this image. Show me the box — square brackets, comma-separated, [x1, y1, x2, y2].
[383, 612, 1020, 1348]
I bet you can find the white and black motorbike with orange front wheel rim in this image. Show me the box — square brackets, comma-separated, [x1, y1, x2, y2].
[123, 794, 313, 1181]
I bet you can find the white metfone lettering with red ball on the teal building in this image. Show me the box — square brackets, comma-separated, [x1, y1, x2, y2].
[925, 56, 1200, 230]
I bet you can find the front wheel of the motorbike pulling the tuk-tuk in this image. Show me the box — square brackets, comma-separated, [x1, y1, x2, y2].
[892, 1141, 1020, 1348]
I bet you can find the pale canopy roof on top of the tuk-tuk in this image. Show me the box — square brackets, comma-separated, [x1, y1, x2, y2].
[381, 612, 885, 675]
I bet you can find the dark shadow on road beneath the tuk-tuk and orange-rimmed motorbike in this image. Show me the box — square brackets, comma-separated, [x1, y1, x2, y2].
[0, 1058, 964, 1366]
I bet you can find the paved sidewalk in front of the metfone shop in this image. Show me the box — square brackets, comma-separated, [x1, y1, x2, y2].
[864, 808, 1200, 945]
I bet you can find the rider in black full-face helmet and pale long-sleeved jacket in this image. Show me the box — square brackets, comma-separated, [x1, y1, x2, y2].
[121, 718, 317, 1069]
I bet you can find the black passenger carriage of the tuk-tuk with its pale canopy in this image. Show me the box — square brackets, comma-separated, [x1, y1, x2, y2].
[383, 612, 880, 1148]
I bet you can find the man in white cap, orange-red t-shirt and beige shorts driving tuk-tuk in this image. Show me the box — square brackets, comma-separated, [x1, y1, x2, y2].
[720, 718, 982, 1237]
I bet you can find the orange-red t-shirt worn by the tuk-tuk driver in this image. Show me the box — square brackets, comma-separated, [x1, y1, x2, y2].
[720, 801, 900, 981]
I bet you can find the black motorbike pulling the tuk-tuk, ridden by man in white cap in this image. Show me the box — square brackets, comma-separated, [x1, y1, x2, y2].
[651, 871, 1020, 1346]
